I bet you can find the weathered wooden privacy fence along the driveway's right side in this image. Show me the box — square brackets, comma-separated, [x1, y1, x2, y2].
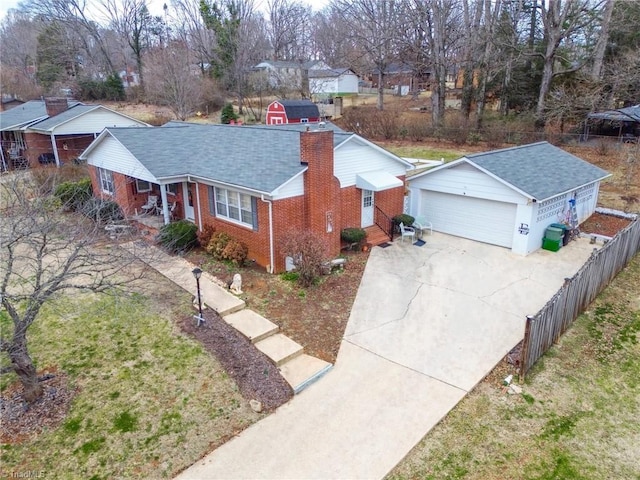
[520, 218, 640, 377]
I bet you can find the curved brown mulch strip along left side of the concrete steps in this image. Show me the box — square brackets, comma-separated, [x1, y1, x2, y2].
[177, 310, 293, 411]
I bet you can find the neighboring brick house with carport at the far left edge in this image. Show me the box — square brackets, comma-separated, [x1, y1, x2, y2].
[0, 98, 149, 170]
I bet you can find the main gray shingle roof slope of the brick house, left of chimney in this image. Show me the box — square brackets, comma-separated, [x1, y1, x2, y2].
[108, 124, 318, 193]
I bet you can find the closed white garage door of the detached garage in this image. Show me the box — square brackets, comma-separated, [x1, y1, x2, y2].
[422, 190, 517, 248]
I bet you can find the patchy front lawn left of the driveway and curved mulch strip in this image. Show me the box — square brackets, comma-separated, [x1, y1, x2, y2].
[0, 276, 261, 479]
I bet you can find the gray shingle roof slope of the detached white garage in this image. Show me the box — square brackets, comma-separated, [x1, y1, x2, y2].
[466, 142, 609, 201]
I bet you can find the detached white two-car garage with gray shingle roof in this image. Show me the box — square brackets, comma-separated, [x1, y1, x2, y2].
[408, 142, 609, 255]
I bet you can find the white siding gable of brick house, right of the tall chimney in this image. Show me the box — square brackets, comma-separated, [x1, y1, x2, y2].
[333, 140, 407, 188]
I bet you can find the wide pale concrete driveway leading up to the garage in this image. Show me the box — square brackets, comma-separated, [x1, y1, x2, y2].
[178, 233, 593, 479]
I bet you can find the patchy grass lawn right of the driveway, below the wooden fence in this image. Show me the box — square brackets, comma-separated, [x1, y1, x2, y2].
[388, 256, 640, 480]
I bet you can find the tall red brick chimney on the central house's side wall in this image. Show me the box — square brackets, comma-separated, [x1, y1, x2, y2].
[300, 130, 340, 255]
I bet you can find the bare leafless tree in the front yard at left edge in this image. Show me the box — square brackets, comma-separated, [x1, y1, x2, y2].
[0, 175, 143, 402]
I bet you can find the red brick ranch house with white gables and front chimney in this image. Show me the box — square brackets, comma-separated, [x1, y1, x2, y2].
[82, 122, 412, 273]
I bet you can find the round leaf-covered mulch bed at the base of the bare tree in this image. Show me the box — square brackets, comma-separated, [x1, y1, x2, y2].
[0, 370, 76, 444]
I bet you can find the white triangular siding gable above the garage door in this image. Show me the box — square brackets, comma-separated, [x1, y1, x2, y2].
[409, 162, 526, 203]
